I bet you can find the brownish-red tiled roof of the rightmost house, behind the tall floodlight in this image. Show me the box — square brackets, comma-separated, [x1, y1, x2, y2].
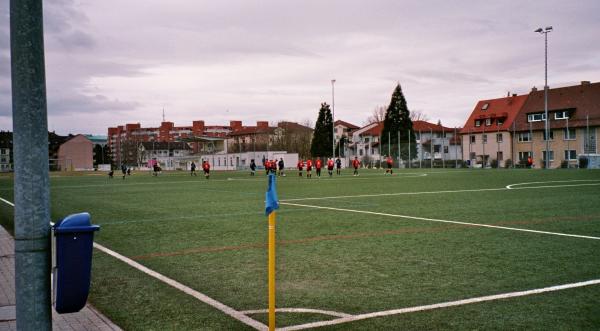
[515, 83, 600, 131]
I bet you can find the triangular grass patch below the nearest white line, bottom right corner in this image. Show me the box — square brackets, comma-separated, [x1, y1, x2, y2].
[320, 285, 600, 331]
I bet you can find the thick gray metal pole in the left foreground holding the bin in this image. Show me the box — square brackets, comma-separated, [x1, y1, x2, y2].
[10, 0, 52, 330]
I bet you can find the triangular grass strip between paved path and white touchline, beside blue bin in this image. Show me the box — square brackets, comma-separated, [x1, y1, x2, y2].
[89, 252, 252, 330]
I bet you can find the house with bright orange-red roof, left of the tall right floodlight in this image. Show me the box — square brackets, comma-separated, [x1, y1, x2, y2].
[460, 94, 528, 168]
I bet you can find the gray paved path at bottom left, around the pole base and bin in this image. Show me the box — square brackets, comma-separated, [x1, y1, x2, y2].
[0, 226, 121, 331]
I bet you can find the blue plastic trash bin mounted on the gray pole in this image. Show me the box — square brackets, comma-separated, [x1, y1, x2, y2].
[52, 213, 100, 314]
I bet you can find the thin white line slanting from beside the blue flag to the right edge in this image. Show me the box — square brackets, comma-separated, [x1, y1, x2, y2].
[279, 201, 600, 240]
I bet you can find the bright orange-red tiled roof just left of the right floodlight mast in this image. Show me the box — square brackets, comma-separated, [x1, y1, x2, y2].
[460, 95, 528, 134]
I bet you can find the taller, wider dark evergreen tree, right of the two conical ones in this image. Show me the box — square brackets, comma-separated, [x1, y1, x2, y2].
[380, 83, 417, 160]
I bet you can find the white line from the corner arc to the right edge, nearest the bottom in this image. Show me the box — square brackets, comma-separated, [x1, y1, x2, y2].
[278, 279, 600, 331]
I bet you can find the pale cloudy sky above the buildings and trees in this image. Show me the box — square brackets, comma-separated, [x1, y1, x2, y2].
[0, 0, 600, 135]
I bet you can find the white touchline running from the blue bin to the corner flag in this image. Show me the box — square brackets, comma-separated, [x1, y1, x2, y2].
[94, 243, 268, 330]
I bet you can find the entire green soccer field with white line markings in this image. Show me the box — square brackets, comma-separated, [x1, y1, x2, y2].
[0, 169, 600, 330]
